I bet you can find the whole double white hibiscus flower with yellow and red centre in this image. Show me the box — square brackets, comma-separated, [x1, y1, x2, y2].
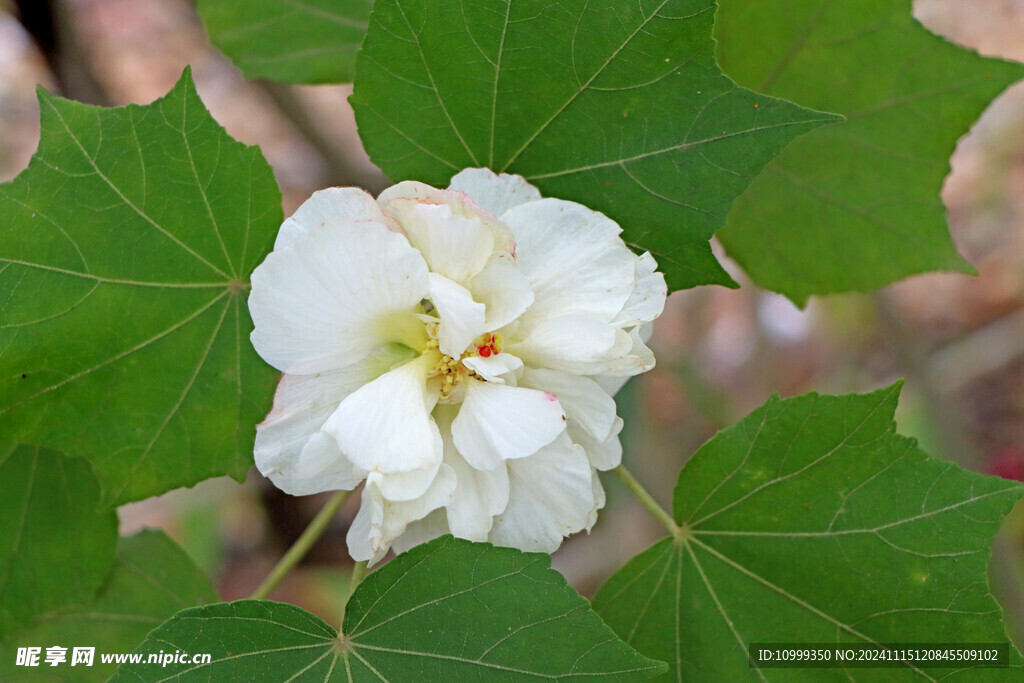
[249, 169, 666, 562]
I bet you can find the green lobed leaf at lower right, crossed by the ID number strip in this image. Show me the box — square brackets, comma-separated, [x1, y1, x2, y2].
[594, 385, 1024, 681]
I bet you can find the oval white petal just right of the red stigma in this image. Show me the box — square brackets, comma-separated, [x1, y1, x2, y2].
[505, 315, 643, 375]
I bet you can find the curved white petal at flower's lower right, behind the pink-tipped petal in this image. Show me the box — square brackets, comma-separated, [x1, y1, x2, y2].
[518, 368, 616, 441]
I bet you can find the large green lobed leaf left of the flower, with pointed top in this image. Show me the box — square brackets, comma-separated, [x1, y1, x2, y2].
[0, 72, 282, 506]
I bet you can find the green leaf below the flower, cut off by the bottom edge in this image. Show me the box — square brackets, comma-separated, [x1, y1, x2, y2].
[114, 537, 665, 681]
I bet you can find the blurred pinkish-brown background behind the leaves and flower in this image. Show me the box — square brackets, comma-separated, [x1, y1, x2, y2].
[0, 0, 1024, 645]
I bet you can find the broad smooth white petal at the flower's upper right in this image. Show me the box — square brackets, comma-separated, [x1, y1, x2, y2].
[502, 199, 637, 322]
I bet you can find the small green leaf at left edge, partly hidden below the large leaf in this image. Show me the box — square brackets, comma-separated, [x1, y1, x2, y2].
[0, 445, 118, 640]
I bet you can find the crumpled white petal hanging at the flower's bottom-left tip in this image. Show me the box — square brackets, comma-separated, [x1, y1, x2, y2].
[346, 465, 456, 565]
